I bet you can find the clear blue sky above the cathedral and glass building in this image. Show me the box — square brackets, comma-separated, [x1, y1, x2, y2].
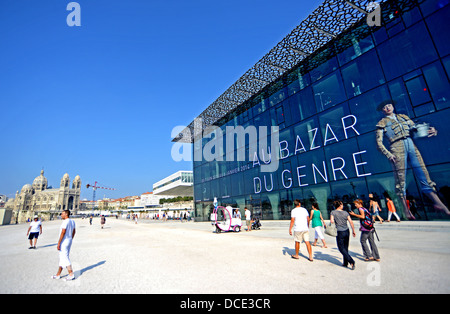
[0, 0, 322, 199]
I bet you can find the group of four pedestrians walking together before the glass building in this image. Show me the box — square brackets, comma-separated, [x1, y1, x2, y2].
[289, 199, 380, 270]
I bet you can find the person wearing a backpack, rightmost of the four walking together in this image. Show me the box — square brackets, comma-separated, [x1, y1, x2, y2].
[350, 199, 380, 262]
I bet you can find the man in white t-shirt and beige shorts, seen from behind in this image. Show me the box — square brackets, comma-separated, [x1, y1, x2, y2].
[289, 199, 313, 262]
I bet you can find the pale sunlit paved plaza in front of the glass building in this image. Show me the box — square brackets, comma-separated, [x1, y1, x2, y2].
[0, 218, 450, 294]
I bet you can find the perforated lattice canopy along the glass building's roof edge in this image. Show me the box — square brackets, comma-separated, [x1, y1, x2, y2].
[173, 0, 387, 143]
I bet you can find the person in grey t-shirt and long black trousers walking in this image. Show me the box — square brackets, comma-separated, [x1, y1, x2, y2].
[330, 201, 356, 270]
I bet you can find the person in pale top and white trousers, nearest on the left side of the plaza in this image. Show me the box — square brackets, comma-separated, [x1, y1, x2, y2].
[52, 210, 76, 280]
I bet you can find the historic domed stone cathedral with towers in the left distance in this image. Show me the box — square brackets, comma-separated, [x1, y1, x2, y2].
[6, 170, 81, 222]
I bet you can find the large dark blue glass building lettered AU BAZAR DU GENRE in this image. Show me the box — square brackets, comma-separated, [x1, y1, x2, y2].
[174, 0, 450, 220]
